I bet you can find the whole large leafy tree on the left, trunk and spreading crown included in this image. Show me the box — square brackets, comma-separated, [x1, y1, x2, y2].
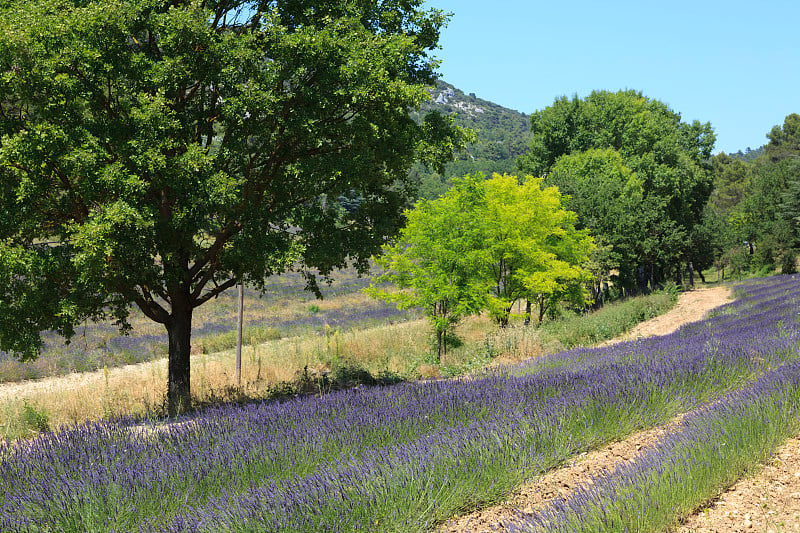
[0, 0, 458, 413]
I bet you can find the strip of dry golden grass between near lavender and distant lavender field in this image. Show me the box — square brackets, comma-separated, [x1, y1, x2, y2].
[0, 286, 696, 441]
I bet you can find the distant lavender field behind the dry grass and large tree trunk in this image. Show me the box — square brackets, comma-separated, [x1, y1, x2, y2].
[0, 268, 417, 382]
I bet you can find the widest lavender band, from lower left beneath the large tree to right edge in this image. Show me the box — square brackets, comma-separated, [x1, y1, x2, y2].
[0, 277, 800, 532]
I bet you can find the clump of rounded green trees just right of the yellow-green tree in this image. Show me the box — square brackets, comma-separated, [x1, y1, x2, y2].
[518, 91, 715, 291]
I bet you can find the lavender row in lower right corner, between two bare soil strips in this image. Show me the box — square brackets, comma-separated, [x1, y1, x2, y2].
[507, 361, 800, 533]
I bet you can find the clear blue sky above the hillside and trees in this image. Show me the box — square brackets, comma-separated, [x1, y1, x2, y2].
[427, 0, 800, 152]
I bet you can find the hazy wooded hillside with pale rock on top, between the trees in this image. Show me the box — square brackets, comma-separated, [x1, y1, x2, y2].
[411, 80, 530, 198]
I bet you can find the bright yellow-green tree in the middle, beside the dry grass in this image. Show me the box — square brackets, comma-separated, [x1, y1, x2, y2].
[368, 174, 594, 356]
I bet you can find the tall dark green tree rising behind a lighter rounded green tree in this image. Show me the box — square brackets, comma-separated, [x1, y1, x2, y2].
[518, 91, 715, 290]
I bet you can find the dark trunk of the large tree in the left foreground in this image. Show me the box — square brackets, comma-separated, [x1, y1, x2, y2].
[166, 297, 192, 416]
